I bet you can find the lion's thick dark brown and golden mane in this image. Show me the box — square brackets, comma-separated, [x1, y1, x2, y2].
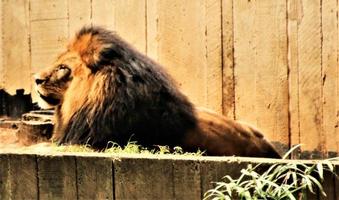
[55, 27, 197, 148]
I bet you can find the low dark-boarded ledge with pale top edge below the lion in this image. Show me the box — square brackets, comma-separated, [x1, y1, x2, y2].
[0, 152, 339, 200]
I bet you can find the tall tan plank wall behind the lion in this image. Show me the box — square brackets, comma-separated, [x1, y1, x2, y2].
[0, 0, 339, 157]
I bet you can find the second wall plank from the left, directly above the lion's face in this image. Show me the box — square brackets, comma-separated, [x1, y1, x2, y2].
[30, 0, 68, 73]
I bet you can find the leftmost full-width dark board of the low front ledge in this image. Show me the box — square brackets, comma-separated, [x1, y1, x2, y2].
[8, 154, 38, 199]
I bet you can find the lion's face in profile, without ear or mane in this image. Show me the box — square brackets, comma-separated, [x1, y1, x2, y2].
[34, 51, 82, 108]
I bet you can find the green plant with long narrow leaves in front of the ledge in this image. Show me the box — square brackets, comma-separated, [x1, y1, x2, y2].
[204, 145, 338, 200]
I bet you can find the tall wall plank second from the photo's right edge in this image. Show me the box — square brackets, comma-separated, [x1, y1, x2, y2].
[298, 1, 323, 158]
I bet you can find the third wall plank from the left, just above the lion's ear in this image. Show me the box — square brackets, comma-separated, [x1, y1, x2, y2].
[68, 0, 92, 37]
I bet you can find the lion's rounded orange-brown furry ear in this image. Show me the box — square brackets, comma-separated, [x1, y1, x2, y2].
[68, 33, 105, 67]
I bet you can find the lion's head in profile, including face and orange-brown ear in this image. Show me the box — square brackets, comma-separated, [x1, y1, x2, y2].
[34, 28, 110, 108]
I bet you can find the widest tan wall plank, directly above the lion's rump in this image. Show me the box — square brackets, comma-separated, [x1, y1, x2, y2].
[233, 0, 289, 153]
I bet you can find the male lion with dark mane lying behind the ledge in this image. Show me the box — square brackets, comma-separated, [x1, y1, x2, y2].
[35, 26, 280, 158]
